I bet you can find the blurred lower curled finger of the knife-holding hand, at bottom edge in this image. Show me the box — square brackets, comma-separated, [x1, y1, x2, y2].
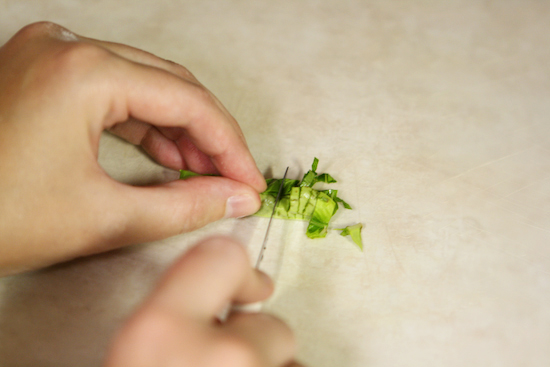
[221, 313, 296, 366]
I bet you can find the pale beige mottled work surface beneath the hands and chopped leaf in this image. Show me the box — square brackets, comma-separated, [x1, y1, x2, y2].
[0, 0, 550, 367]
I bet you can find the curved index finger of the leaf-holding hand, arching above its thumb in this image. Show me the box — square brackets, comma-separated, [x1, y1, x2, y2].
[105, 55, 265, 192]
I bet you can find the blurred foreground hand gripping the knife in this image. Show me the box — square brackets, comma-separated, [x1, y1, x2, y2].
[106, 238, 299, 367]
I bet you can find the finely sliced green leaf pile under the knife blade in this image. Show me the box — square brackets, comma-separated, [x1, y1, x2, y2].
[180, 158, 363, 249]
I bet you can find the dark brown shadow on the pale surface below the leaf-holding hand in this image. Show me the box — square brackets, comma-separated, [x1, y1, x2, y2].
[0, 249, 164, 367]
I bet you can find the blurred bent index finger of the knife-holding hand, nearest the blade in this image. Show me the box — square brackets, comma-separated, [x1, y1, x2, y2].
[151, 237, 273, 322]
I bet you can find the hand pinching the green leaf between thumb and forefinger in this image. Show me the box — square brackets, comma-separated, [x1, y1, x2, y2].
[0, 23, 265, 274]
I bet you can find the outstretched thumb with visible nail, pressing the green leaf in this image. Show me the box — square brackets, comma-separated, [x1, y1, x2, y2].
[103, 177, 261, 245]
